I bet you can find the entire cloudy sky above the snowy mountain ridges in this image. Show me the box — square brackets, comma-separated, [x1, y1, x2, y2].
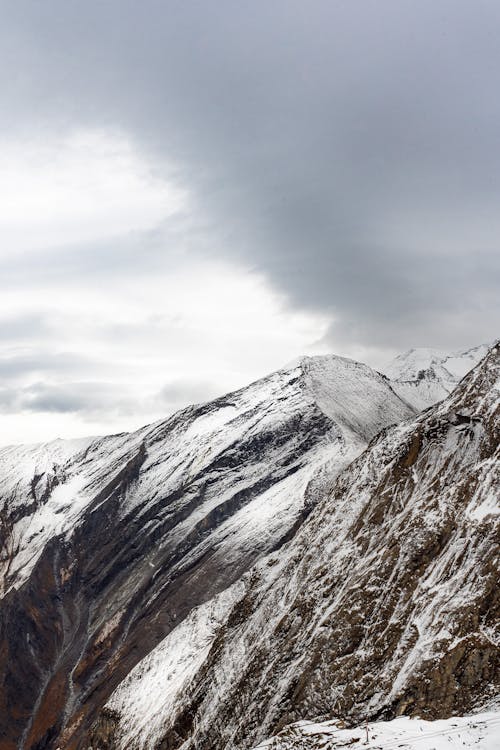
[0, 0, 500, 444]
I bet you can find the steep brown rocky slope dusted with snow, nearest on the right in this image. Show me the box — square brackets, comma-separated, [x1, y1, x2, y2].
[92, 344, 500, 750]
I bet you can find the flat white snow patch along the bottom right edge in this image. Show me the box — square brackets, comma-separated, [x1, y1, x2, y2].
[254, 712, 500, 750]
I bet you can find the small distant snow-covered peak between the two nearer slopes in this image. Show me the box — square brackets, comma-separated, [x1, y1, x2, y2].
[383, 344, 489, 411]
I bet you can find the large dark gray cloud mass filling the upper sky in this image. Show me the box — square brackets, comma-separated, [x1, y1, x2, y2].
[0, 0, 500, 388]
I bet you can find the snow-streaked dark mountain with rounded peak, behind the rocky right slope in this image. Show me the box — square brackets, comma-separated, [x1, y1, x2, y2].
[0, 356, 414, 750]
